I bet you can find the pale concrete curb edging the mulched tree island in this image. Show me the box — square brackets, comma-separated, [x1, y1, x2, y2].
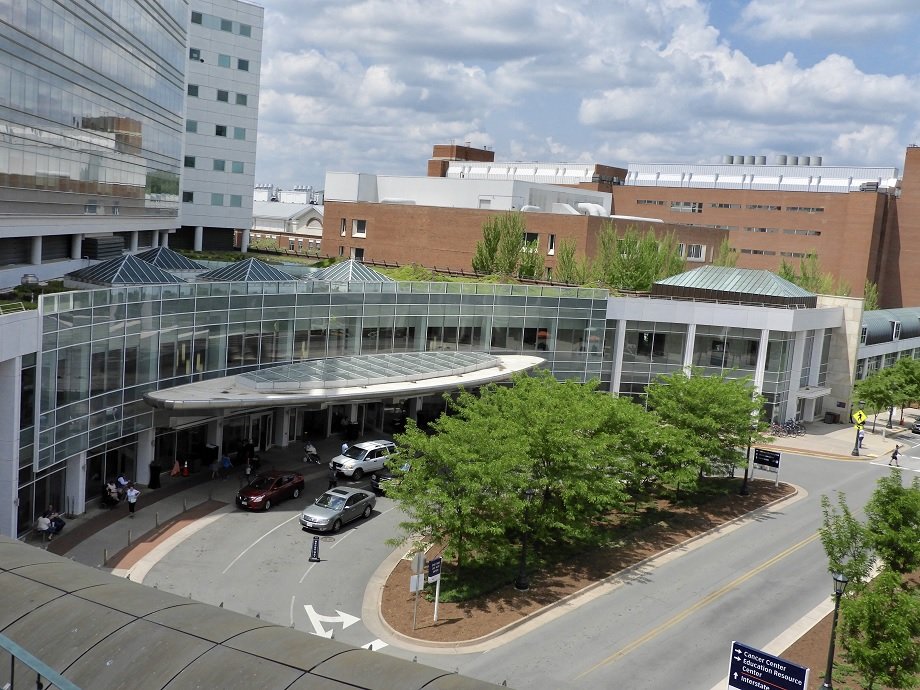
[361, 484, 808, 654]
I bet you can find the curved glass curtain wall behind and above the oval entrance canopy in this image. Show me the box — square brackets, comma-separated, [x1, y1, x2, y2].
[36, 282, 612, 468]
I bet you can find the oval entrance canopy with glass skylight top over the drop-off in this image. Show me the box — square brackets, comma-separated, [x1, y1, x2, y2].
[144, 352, 544, 411]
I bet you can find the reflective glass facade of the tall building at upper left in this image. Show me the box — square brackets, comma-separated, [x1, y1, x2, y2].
[0, 0, 188, 255]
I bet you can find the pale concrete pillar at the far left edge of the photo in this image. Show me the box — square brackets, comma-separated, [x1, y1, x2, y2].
[0, 357, 22, 539]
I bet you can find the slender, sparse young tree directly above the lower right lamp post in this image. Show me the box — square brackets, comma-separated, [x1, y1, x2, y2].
[818, 492, 875, 589]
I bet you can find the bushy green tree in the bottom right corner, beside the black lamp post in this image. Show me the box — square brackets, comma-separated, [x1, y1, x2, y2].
[840, 570, 920, 690]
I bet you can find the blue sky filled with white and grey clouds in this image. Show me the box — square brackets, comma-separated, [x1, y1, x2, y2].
[256, 0, 920, 188]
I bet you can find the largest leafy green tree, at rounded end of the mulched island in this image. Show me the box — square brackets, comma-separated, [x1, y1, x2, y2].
[388, 371, 627, 566]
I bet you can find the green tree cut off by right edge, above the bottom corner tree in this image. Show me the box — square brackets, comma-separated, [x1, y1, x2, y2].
[866, 469, 920, 573]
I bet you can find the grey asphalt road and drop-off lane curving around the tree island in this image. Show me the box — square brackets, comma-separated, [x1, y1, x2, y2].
[144, 447, 920, 690]
